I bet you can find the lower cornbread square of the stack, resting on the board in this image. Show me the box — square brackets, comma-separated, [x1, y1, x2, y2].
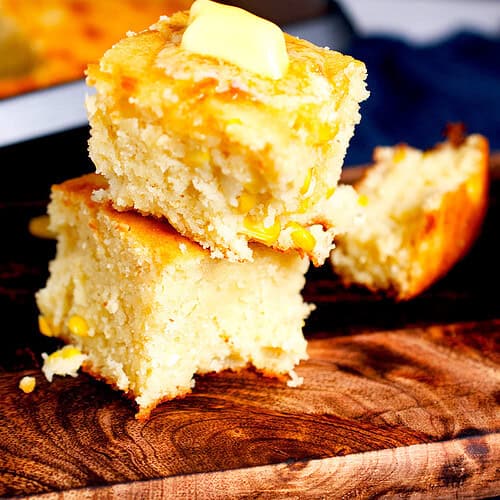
[36, 174, 312, 417]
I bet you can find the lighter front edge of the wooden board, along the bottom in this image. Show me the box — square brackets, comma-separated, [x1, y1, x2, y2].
[30, 434, 500, 500]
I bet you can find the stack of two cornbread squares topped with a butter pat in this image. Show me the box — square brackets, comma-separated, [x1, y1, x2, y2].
[37, 0, 367, 417]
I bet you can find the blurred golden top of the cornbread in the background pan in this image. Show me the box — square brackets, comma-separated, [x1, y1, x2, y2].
[0, 0, 192, 97]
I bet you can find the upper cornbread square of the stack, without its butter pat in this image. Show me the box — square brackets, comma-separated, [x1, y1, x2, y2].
[87, 7, 368, 265]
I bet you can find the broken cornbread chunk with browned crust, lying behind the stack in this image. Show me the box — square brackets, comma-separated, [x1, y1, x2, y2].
[331, 134, 489, 300]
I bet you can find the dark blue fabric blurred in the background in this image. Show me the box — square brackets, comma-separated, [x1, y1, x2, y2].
[345, 33, 500, 165]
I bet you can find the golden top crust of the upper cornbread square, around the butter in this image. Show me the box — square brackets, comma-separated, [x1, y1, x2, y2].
[88, 11, 365, 98]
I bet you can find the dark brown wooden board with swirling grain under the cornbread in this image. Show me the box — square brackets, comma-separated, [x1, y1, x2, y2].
[0, 139, 500, 499]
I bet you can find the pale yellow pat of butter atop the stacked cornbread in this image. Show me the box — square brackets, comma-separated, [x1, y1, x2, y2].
[181, 0, 288, 79]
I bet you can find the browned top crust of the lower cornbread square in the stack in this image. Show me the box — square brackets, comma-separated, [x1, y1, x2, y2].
[52, 174, 205, 262]
